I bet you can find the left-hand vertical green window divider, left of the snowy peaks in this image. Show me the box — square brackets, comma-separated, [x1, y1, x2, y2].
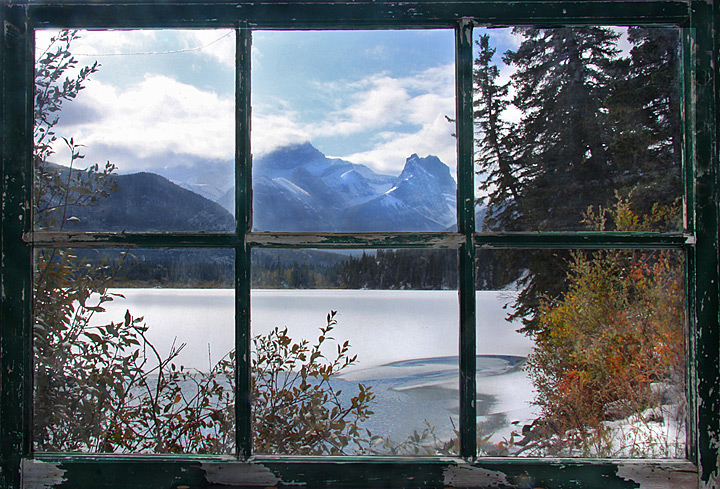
[235, 25, 252, 459]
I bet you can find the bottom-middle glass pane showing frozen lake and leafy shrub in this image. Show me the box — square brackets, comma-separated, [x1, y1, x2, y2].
[252, 250, 459, 456]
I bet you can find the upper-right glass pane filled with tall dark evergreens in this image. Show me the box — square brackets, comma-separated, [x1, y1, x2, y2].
[474, 26, 684, 231]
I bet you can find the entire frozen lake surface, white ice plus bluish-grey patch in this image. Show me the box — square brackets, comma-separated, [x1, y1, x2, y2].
[95, 289, 533, 450]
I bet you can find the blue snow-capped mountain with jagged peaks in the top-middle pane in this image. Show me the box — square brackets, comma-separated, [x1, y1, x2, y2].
[218, 143, 456, 232]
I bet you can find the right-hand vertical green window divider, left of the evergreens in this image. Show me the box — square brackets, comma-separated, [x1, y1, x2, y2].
[455, 19, 477, 460]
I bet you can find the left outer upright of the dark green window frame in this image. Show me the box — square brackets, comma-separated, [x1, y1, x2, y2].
[0, 5, 34, 487]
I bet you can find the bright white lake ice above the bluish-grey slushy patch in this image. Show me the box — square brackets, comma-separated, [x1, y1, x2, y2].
[107, 289, 532, 370]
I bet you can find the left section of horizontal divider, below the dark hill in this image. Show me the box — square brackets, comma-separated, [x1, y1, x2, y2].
[23, 231, 238, 248]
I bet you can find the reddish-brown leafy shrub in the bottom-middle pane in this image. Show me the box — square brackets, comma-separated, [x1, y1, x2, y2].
[252, 311, 375, 455]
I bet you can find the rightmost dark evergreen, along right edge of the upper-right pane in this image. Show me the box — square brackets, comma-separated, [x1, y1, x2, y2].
[608, 27, 682, 218]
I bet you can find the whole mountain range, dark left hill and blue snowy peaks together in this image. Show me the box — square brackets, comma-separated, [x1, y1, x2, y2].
[53, 143, 456, 232]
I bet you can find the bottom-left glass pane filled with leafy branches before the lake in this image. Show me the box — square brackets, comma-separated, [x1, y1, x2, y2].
[33, 249, 235, 454]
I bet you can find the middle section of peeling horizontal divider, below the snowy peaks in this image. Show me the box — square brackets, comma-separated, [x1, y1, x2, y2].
[247, 232, 465, 248]
